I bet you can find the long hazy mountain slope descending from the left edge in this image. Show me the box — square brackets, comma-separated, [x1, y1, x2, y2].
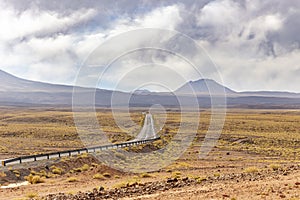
[0, 70, 119, 106]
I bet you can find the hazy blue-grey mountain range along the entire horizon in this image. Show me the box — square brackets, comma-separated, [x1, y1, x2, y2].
[0, 70, 300, 108]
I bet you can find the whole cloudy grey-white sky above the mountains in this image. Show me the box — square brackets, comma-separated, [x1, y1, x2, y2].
[0, 0, 300, 92]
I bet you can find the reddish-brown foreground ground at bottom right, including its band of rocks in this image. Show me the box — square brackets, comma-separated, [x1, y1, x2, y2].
[43, 165, 300, 200]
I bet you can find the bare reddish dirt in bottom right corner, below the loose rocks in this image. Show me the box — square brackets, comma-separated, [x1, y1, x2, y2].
[122, 171, 300, 200]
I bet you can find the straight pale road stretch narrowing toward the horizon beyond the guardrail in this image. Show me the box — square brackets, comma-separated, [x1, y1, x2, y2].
[133, 114, 157, 141]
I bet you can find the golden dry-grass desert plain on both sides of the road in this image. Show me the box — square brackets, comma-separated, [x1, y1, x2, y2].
[0, 107, 300, 199]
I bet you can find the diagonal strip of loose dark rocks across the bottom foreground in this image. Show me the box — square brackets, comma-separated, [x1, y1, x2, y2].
[43, 165, 300, 200]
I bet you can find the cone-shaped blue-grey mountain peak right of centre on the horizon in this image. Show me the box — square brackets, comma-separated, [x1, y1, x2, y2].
[175, 79, 236, 95]
